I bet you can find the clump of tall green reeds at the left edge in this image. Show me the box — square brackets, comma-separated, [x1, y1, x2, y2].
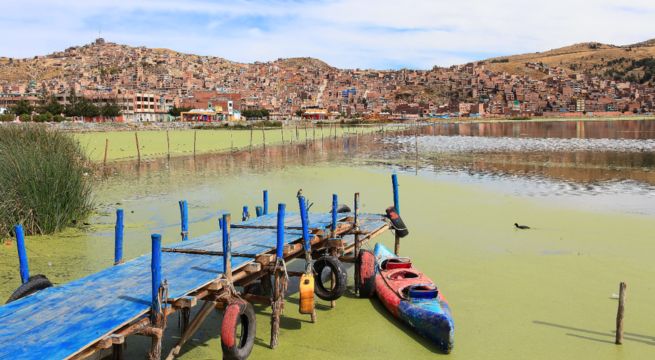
[0, 124, 93, 238]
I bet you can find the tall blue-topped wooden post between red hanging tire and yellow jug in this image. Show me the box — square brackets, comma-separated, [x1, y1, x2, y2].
[270, 204, 286, 349]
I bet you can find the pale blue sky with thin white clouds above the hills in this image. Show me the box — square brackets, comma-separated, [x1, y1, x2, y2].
[0, 0, 655, 69]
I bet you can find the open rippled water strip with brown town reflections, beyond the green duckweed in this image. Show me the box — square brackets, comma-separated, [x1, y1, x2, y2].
[97, 120, 655, 213]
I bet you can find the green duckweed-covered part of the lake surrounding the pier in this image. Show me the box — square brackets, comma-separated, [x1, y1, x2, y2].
[0, 121, 655, 359]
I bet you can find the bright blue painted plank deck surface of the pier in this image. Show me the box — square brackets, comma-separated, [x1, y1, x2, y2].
[0, 213, 388, 360]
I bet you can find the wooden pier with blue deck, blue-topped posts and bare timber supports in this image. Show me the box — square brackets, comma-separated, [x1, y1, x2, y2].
[0, 177, 398, 359]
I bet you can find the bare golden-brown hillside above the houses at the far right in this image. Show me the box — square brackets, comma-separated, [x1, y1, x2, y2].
[485, 39, 655, 80]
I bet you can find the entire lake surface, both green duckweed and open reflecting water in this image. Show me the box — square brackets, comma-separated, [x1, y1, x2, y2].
[0, 121, 655, 359]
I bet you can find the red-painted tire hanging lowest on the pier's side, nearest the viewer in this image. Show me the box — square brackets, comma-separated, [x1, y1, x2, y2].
[221, 300, 257, 360]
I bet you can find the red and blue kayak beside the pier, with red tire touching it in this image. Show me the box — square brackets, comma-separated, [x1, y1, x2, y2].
[357, 243, 455, 353]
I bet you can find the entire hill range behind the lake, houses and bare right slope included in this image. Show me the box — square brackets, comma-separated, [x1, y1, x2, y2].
[0, 39, 655, 117]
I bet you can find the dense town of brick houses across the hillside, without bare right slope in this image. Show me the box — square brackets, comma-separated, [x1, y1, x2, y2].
[0, 38, 655, 122]
